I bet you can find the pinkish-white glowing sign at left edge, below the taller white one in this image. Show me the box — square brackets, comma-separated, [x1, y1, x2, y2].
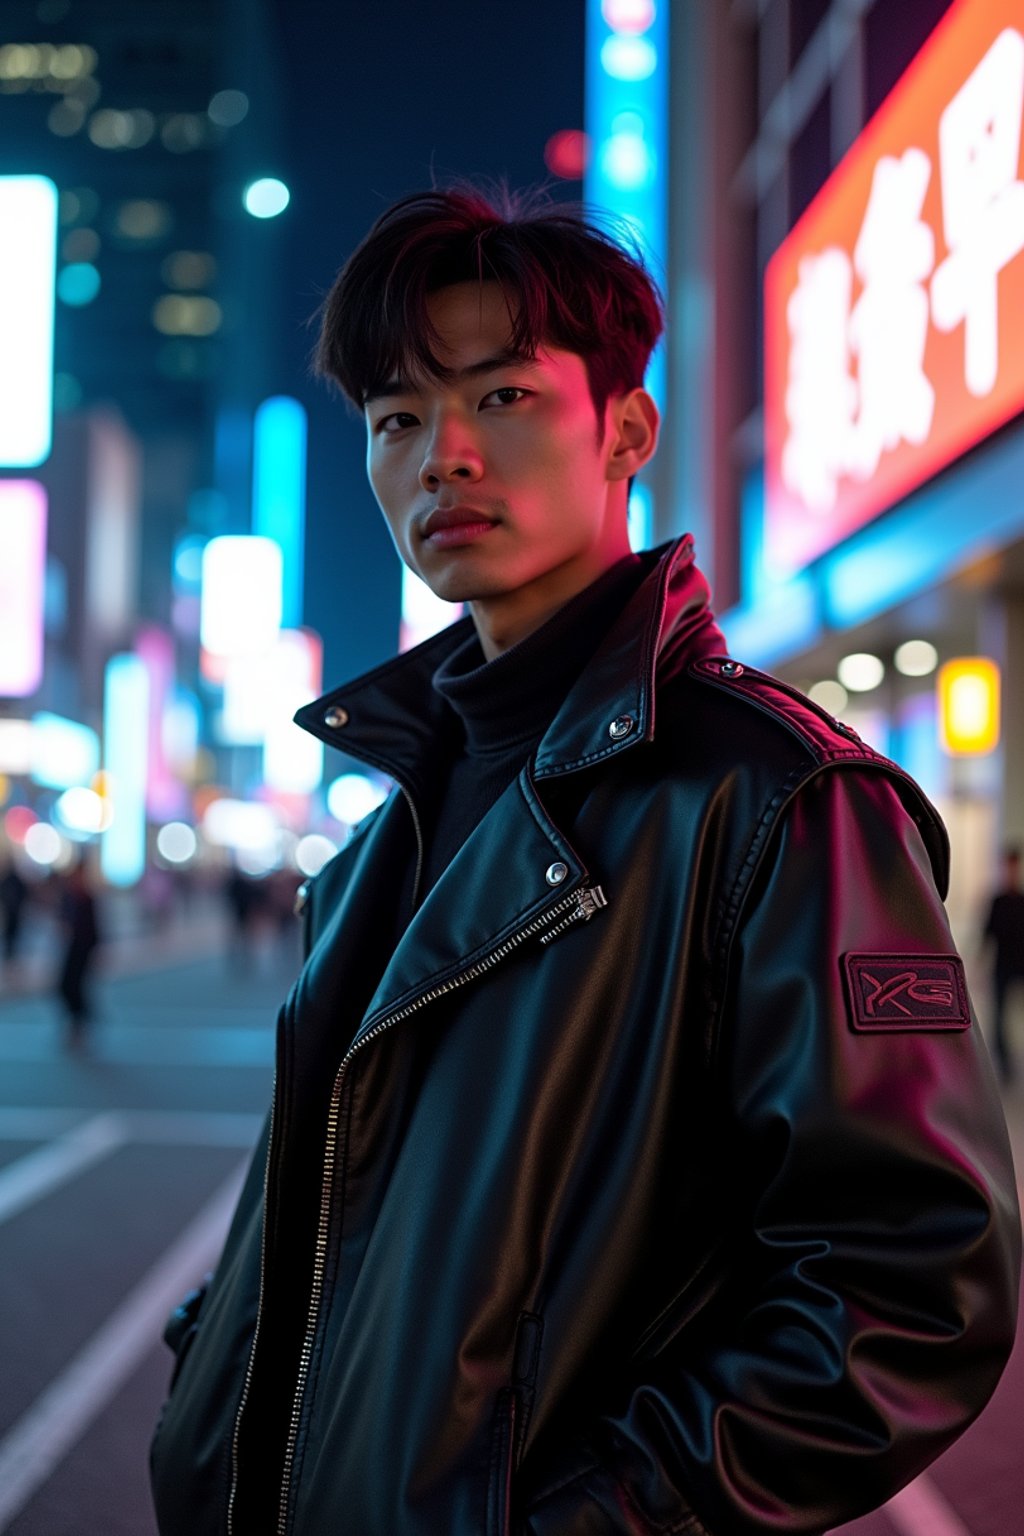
[0, 479, 46, 699]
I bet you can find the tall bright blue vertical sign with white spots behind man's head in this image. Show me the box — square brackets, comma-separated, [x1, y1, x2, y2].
[583, 0, 669, 410]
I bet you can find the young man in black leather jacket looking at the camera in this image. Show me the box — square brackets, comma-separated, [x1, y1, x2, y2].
[154, 192, 1018, 1536]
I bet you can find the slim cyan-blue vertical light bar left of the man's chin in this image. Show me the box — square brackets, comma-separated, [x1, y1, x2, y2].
[252, 395, 306, 630]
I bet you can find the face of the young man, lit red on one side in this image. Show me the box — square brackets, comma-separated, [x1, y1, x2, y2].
[365, 283, 649, 629]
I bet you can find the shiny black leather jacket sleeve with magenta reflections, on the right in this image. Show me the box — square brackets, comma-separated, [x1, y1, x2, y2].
[524, 768, 1019, 1536]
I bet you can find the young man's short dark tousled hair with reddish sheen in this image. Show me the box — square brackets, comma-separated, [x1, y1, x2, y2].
[313, 186, 663, 422]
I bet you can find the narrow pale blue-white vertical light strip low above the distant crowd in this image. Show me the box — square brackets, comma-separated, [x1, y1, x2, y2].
[100, 653, 149, 886]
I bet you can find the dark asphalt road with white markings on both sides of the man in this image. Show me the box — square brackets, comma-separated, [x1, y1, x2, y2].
[0, 933, 1024, 1536]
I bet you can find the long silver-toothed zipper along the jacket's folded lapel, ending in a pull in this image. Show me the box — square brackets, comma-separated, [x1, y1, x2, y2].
[274, 884, 608, 1536]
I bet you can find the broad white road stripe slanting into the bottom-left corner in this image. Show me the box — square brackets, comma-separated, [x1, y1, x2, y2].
[0, 1164, 244, 1531]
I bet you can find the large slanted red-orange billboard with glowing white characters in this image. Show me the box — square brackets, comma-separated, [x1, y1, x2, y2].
[765, 0, 1024, 576]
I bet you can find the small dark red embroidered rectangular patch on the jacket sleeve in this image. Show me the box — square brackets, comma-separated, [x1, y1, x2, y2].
[843, 955, 970, 1031]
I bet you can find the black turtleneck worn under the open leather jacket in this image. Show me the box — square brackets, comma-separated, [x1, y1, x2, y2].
[405, 554, 646, 911]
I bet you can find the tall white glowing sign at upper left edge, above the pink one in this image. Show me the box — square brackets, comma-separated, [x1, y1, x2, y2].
[0, 177, 57, 468]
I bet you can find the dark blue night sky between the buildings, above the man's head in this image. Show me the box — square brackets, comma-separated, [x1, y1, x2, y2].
[267, 0, 585, 685]
